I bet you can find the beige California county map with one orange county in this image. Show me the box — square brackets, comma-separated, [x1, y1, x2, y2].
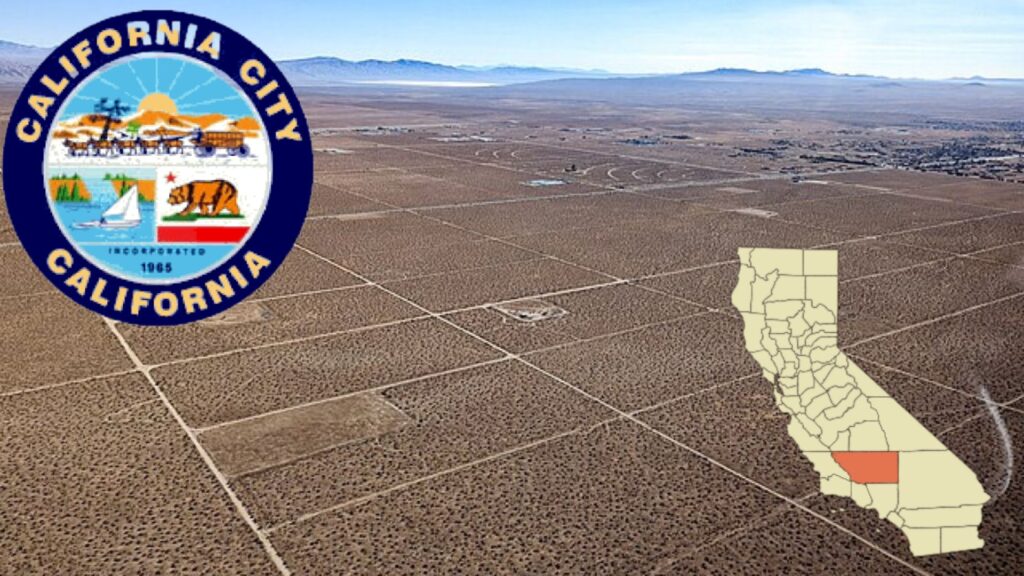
[732, 248, 989, 556]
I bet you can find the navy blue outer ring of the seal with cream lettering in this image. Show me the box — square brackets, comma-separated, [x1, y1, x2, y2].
[3, 10, 313, 325]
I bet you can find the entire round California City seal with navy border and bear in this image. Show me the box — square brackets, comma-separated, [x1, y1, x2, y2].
[3, 10, 312, 325]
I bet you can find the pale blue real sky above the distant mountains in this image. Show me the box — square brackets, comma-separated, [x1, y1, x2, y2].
[0, 0, 1024, 78]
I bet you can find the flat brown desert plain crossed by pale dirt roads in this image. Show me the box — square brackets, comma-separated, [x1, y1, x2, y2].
[0, 80, 1024, 575]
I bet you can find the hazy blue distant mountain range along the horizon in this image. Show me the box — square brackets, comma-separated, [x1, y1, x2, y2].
[0, 40, 1024, 87]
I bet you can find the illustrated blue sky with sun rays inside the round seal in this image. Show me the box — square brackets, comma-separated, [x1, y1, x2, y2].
[61, 57, 256, 120]
